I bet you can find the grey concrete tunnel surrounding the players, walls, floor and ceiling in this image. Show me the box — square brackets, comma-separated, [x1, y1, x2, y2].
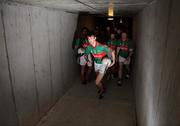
[0, 0, 180, 126]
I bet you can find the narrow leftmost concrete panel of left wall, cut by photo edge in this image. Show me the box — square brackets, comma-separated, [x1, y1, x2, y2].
[0, 5, 18, 126]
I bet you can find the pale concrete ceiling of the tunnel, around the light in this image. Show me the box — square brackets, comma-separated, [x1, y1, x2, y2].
[7, 0, 154, 16]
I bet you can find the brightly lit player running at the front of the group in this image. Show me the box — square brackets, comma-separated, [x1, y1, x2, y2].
[85, 34, 115, 99]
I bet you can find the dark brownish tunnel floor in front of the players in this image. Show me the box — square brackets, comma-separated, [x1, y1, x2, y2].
[37, 77, 136, 126]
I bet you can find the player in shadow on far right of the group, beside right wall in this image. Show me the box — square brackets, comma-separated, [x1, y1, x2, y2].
[117, 32, 133, 86]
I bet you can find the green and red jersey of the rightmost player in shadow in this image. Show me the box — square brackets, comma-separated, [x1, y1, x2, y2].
[116, 40, 131, 58]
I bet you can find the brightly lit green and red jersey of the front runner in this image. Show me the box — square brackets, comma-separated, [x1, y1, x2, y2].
[85, 42, 109, 64]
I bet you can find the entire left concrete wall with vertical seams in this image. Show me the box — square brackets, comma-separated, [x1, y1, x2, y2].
[0, 4, 77, 126]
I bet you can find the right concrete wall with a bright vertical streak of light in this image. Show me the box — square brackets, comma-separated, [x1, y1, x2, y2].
[134, 0, 180, 126]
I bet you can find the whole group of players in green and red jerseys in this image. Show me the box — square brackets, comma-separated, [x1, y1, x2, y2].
[74, 27, 133, 99]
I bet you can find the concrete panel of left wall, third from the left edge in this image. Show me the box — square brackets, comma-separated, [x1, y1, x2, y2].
[29, 8, 52, 114]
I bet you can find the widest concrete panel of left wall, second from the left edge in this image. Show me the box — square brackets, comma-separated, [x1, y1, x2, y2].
[3, 3, 38, 125]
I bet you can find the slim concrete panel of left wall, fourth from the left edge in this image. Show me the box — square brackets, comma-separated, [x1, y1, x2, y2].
[47, 12, 63, 103]
